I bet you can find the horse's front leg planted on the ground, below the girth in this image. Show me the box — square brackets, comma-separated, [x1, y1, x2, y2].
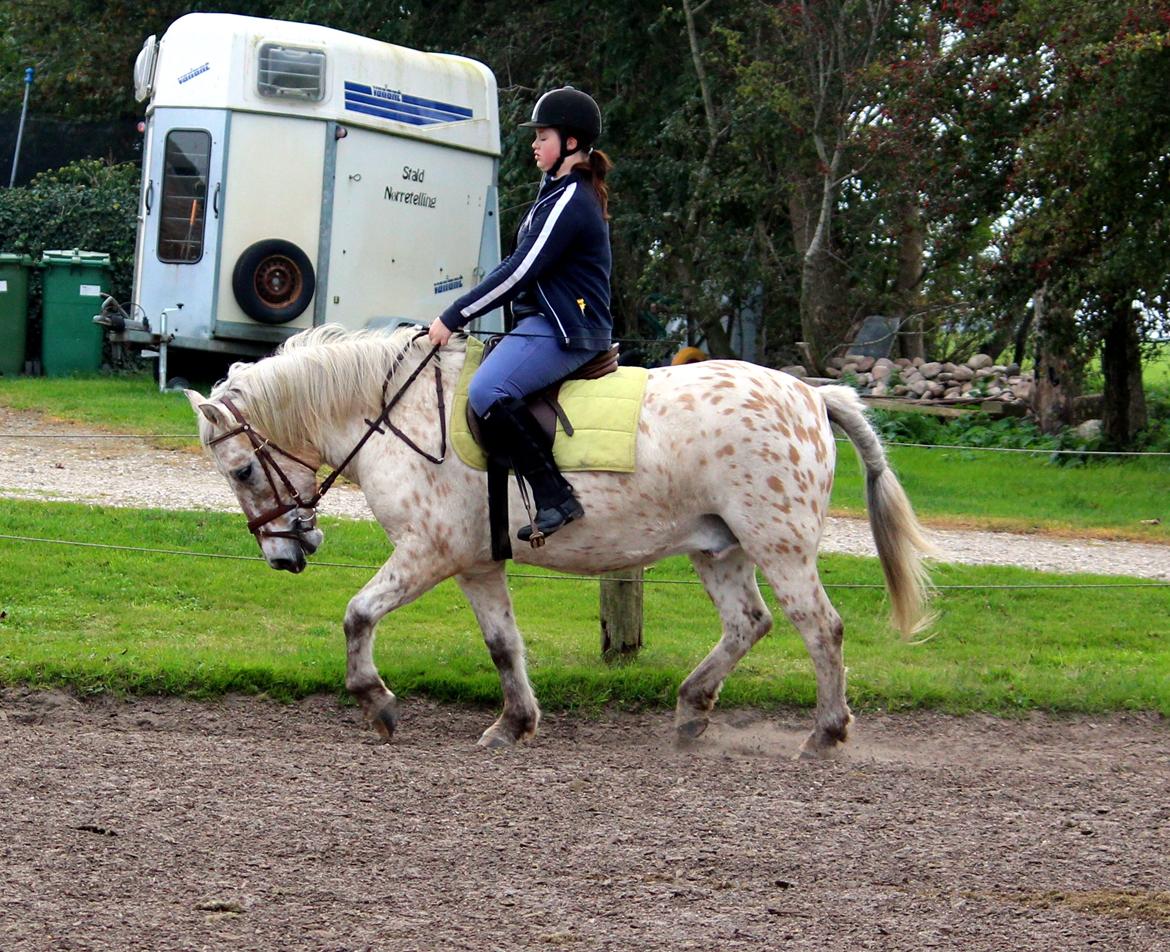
[455, 563, 541, 747]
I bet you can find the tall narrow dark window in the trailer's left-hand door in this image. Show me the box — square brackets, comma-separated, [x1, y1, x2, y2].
[158, 129, 212, 264]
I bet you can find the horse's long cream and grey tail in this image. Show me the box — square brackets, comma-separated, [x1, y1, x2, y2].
[817, 386, 936, 635]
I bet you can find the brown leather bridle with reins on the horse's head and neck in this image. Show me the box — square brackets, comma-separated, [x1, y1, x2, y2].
[207, 331, 447, 549]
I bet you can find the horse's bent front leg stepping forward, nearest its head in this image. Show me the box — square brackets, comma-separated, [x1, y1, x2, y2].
[345, 552, 447, 740]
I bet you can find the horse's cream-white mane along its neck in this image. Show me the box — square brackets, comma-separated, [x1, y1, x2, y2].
[205, 324, 466, 446]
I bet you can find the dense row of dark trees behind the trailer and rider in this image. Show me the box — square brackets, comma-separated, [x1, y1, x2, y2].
[0, 0, 1170, 416]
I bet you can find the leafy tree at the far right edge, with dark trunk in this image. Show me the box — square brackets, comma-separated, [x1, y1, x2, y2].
[1007, 0, 1170, 447]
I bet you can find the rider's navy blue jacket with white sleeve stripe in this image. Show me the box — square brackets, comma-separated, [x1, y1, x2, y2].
[439, 171, 613, 351]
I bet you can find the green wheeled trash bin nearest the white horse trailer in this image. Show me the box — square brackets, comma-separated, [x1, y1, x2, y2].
[41, 251, 110, 377]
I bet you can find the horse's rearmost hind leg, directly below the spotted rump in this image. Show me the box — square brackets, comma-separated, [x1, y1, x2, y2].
[761, 552, 853, 757]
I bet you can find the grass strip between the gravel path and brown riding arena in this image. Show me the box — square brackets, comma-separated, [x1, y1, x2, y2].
[0, 501, 1170, 715]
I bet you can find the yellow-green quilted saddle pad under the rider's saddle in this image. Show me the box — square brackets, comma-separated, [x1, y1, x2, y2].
[450, 337, 646, 472]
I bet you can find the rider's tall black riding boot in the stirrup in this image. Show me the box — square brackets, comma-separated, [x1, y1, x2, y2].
[481, 396, 585, 545]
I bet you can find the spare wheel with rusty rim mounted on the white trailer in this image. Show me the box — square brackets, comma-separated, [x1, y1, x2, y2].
[232, 239, 317, 324]
